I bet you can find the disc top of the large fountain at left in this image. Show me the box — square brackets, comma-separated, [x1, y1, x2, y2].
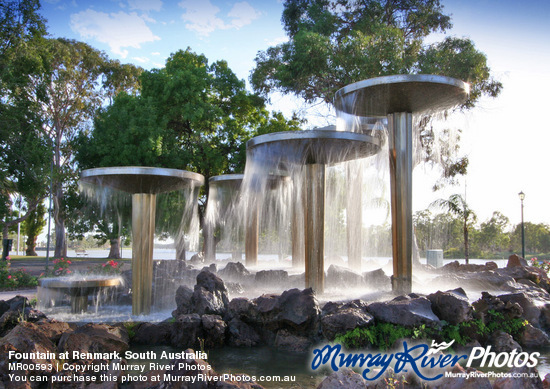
[81, 166, 208, 193]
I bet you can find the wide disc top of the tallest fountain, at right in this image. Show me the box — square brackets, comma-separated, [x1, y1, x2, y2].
[334, 74, 470, 116]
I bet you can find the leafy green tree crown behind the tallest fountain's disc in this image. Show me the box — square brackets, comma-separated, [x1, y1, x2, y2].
[251, 0, 502, 107]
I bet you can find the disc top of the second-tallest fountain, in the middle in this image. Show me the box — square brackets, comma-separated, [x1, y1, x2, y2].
[246, 130, 380, 165]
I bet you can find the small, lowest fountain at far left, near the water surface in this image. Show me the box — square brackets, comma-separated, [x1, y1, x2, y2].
[38, 275, 123, 313]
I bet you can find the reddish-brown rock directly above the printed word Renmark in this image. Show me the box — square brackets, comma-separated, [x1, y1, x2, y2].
[58, 323, 129, 354]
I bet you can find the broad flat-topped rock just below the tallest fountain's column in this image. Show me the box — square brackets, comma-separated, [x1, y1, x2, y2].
[367, 296, 439, 327]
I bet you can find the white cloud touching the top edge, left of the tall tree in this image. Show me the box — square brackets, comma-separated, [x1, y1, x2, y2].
[178, 0, 260, 36]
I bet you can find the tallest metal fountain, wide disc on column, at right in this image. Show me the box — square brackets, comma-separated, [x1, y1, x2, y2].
[334, 74, 469, 294]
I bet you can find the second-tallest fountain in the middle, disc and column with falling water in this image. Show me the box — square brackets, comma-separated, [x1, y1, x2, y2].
[247, 129, 380, 293]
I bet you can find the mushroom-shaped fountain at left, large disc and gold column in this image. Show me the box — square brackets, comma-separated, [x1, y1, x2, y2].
[81, 166, 204, 315]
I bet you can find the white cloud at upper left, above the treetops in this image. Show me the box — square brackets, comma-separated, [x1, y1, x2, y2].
[70, 9, 160, 58]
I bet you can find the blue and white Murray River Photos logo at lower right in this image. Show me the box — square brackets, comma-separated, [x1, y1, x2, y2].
[311, 340, 540, 381]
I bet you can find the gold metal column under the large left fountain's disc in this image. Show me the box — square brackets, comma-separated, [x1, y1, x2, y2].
[132, 193, 157, 315]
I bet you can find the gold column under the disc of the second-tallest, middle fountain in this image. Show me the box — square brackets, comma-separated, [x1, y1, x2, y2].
[304, 164, 326, 293]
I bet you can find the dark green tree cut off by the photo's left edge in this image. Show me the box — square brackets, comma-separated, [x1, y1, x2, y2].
[0, 0, 49, 238]
